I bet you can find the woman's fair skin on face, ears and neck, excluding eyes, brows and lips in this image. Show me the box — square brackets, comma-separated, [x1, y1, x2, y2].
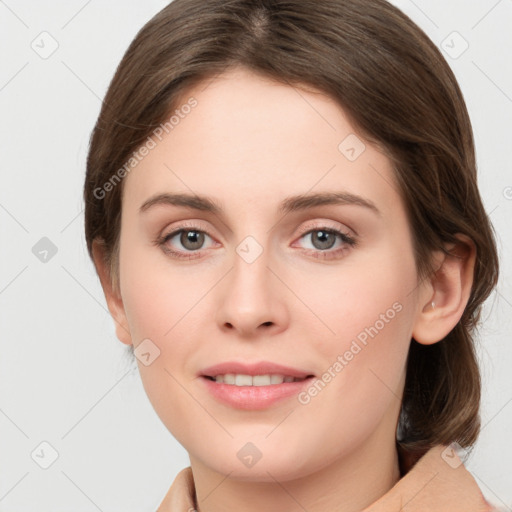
[94, 68, 475, 512]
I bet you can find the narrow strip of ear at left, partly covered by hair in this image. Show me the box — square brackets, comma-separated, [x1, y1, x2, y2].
[92, 240, 132, 345]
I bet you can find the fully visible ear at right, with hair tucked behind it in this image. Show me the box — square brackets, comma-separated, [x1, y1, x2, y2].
[412, 233, 476, 345]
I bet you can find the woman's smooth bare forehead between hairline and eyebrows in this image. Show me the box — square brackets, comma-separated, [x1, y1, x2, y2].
[123, 68, 400, 219]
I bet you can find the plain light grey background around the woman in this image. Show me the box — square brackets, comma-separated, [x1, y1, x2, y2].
[0, 0, 512, 512]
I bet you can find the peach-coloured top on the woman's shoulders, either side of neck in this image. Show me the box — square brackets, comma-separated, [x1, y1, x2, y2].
[157, 446, 498, 512]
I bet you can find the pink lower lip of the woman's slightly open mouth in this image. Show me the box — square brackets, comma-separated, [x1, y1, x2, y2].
[201, 377, 314, 410]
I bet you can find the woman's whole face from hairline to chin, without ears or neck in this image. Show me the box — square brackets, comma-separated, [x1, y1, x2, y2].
[119, 69, 428, 481]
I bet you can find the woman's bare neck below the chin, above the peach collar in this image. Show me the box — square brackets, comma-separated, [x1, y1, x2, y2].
[190, 435, 400, 512]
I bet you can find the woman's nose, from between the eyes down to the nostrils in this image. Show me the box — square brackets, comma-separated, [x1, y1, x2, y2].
[216, 244, 288, 338]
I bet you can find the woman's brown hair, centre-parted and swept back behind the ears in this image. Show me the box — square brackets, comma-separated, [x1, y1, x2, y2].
[84, 0, 498, 451]
